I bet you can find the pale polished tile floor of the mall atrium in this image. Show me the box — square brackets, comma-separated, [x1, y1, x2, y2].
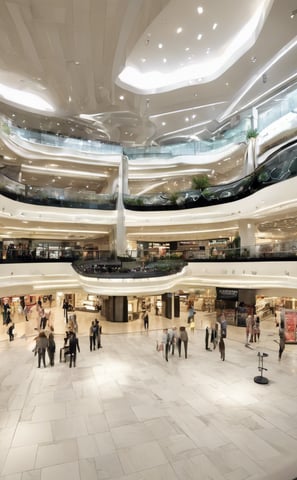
[0, 309, 297, 480]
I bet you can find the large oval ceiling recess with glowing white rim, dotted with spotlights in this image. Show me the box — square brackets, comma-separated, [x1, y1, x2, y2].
[117, 0, 272, 94]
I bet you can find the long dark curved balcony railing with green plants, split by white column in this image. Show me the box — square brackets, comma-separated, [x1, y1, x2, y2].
[0, 141, 297, 211]
